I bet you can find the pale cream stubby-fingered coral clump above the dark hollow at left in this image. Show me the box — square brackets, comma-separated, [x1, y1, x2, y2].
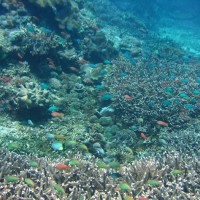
[14, 82, 50, 108]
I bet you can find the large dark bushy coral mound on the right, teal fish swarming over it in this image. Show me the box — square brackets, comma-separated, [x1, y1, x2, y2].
[104, 54, 199, 127]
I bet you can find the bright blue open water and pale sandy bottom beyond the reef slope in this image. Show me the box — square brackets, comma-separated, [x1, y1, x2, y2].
[111, 0, 200, 56]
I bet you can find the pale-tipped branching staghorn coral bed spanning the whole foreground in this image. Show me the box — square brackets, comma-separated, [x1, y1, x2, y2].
[0, 150, 200, 200]
